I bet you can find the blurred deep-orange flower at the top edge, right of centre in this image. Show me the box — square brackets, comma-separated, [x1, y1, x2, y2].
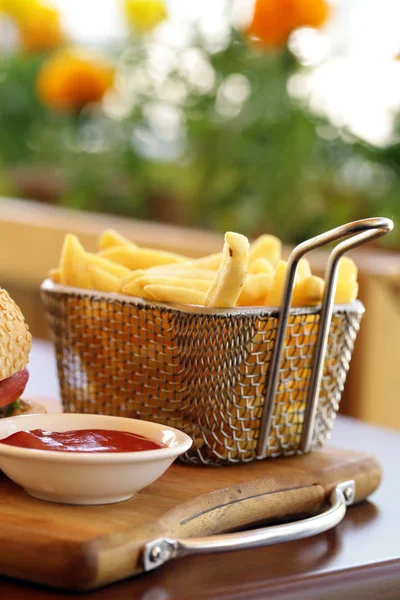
[247, 0, 329, 47]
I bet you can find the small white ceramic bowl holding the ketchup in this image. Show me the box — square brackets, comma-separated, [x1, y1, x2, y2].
[0, 414, 192, 504]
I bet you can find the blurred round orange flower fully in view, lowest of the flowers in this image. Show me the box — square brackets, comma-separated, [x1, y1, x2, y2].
[36, 50, 113, 112]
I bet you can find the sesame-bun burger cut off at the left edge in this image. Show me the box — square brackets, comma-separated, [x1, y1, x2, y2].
[0, 288, 45, 418]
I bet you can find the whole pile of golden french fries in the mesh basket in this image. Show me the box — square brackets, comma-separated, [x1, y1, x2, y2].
[50, 229, 358, 308]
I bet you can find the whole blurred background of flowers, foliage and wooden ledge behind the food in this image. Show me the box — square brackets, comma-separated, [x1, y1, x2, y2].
[0, 0, 400, 427]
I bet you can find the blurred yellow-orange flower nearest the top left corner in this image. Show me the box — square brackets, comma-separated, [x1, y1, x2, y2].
[18, 2, 64, 52]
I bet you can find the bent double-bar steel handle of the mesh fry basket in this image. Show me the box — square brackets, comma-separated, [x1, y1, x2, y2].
[257, 217, 394, 459]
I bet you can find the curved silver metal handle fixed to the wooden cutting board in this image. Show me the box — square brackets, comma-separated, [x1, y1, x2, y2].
[143, 480, 355, 571]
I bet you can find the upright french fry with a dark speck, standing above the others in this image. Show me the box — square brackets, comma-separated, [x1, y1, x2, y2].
[205, 231, 249, 308]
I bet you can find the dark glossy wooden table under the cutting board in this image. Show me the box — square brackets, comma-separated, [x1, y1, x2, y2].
[0, 341, 400, 600]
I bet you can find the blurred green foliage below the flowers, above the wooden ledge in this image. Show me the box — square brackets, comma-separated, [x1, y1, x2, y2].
[0, 30, 400, 245]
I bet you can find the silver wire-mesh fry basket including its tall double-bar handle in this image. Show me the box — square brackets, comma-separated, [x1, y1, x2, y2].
[41, 218, 393, 465]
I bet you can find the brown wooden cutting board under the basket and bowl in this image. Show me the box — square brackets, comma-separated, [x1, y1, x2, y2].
[0, 448, 381, 590]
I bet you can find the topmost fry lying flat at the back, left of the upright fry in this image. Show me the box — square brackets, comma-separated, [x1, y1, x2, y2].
[98, 246, 188, 270]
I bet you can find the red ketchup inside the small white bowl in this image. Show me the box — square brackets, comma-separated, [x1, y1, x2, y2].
[0, 429, 167, 453]
